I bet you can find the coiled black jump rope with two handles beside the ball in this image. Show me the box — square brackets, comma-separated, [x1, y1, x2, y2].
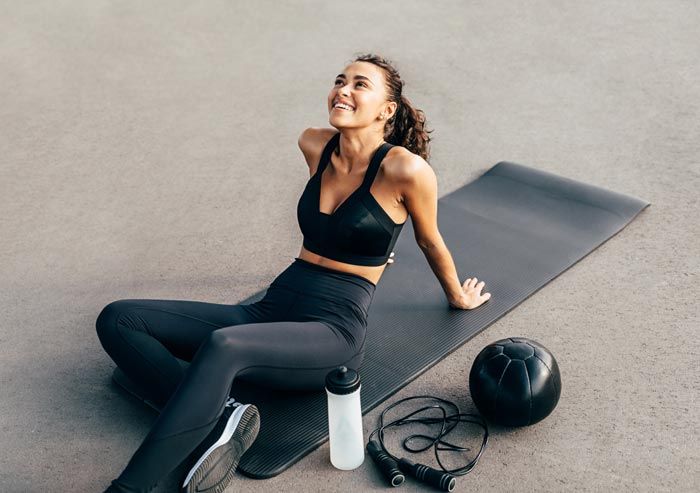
[367, 395, 489, 491]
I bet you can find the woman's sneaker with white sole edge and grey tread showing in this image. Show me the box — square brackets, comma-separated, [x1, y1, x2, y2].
[181, 398, 260, 493]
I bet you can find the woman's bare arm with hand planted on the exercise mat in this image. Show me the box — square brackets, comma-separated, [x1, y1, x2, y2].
[403, 154, 491, 309]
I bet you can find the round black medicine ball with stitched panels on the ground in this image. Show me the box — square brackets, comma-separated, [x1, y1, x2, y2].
[469, 337, 561, 426]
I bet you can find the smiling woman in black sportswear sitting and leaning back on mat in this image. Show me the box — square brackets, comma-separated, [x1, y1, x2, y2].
[96, 55, 490, 493]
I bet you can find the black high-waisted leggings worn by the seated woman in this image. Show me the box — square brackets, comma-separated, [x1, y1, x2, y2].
[96, 258, 375, 491]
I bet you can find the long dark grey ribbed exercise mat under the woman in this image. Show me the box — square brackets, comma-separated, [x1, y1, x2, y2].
[219, 162, 649, 479]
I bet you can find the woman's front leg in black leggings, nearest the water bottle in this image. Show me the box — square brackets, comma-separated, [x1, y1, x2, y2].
[116, 321, 358, 491]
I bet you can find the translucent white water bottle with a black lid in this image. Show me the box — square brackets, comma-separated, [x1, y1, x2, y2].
[326, 366, 365, 471]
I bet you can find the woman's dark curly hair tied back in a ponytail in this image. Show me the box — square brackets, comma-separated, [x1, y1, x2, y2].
[354, 53, 433, 161]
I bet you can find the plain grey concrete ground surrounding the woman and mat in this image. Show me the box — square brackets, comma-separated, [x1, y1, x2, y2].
[0, 0, 700, 492]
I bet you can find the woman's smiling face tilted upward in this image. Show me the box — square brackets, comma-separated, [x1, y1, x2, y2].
[328, 62, 392, 129]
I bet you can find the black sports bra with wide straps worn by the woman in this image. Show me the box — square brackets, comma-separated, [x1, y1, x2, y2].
[297, 133, 405, 266]
